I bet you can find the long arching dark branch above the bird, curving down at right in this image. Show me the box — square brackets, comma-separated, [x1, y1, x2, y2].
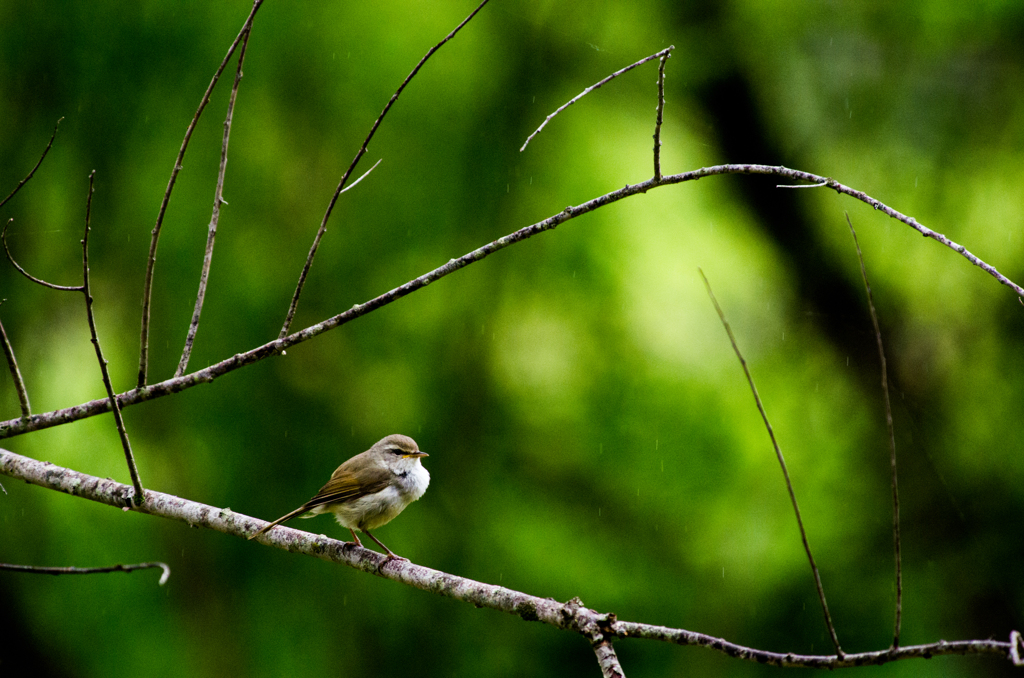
[0, 165, 1024, 439]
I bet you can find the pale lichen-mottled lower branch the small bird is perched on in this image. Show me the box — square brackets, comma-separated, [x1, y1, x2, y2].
[0, 449, 1024, 669]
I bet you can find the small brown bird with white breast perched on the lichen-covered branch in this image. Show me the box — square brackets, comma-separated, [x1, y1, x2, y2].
[249, 434, 430, 558]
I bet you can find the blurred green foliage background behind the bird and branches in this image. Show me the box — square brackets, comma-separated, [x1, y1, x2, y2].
[0, 0, 1024, 676]
